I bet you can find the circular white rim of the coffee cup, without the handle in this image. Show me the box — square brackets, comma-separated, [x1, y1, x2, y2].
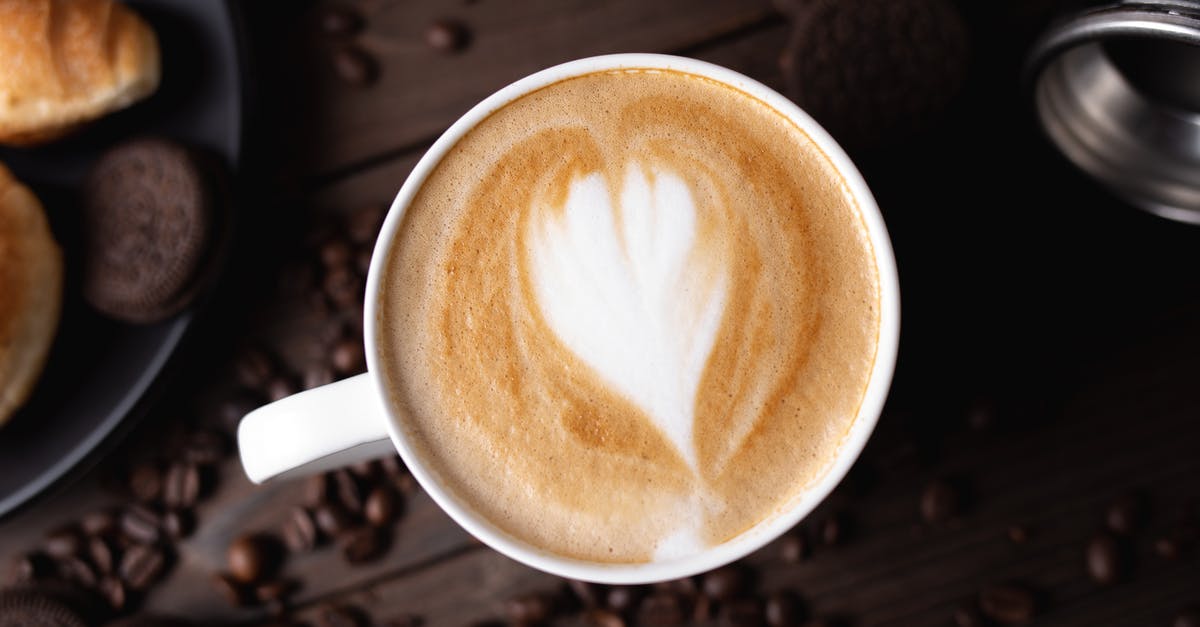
[364, 53, 900, 584]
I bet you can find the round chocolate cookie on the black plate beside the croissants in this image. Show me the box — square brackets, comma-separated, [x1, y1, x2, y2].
[83, 138, 215, 323]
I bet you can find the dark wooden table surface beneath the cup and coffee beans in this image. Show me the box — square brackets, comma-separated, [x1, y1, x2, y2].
[0, 0, 1200, 626]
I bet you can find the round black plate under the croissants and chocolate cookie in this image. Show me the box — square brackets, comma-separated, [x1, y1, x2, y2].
[0, 0, 242, 516]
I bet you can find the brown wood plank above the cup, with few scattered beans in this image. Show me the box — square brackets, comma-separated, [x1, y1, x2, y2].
[290, 0, 778, 173]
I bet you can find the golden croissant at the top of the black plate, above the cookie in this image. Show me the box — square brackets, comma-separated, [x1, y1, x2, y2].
[0, 0, 161, 145]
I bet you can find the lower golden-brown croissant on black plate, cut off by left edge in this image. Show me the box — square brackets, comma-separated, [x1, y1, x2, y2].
[0, 163, 62, 425]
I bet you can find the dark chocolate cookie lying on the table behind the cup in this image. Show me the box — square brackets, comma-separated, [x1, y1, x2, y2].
[780, 0, 968, 151]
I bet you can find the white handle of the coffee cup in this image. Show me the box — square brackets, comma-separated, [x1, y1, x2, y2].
[238, 374, 396, 483]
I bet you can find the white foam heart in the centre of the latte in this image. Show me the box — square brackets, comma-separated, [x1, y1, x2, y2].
[528, 167, 727, 468]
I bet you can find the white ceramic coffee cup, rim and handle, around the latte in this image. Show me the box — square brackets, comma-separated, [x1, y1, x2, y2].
[238, 54, 900, 584]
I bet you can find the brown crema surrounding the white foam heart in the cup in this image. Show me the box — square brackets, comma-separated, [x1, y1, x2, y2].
[376, 70, 880, 562]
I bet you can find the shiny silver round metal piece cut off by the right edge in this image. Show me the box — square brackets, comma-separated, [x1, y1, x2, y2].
[1026, 0, 1200, 223]
